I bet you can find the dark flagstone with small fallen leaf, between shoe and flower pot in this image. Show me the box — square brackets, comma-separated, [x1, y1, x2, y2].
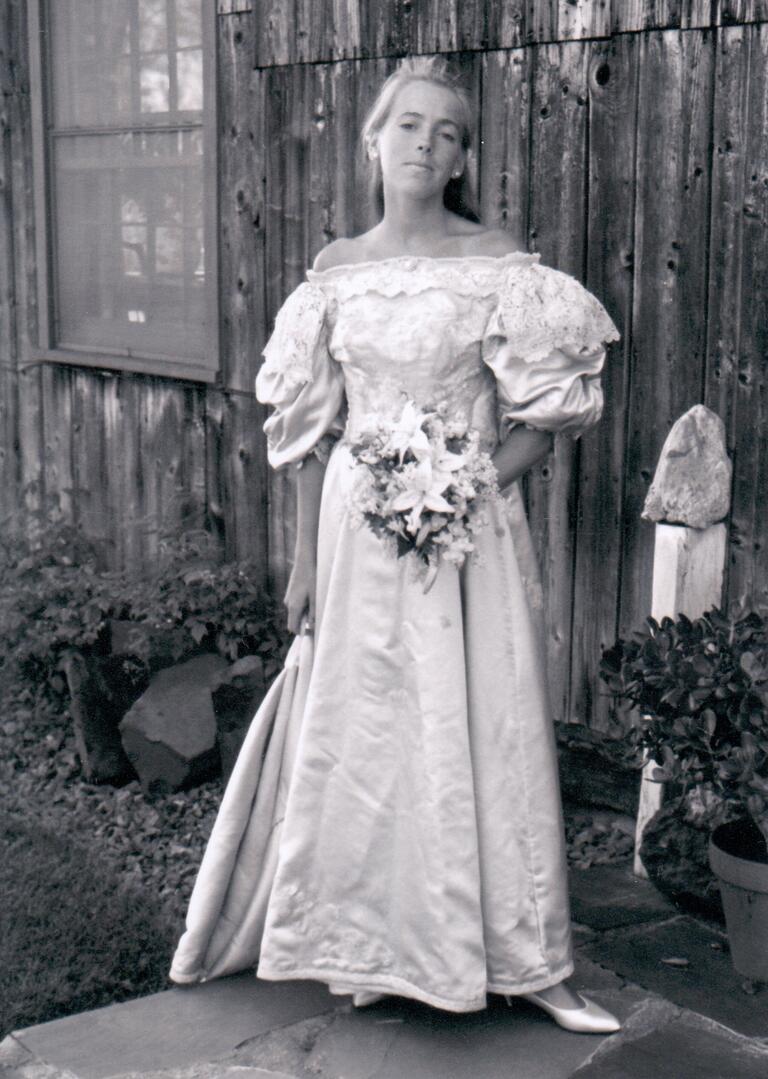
[580, 915, 768, 1035]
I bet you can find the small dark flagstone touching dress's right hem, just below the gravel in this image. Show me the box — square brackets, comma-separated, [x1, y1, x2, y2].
[568, 862, 677, 929]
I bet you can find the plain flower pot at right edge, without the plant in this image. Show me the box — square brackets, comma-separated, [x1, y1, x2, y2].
[710, 820, 768, 982]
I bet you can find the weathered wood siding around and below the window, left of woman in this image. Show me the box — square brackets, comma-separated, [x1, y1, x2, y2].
[0, 0, 269, 583]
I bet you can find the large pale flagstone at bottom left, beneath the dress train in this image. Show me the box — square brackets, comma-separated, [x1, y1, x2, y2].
[13, 972, 339, 1079]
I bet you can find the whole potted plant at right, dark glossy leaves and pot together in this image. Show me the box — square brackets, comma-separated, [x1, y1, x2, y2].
[601, 607, 768, 981]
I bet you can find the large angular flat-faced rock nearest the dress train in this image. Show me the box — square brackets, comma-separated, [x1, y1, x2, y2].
[120, 654, 228, 794]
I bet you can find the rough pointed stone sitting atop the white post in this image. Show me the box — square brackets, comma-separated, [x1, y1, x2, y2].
[642, 405, 731, 529]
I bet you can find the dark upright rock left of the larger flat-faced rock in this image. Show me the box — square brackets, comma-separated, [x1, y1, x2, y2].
[63, 651, 141, 783]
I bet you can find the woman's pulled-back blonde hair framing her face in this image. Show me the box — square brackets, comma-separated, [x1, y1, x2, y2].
[360, 56, 480, 221]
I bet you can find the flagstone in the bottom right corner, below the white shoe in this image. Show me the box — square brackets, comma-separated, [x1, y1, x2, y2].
[573, 1015, 768, 1079]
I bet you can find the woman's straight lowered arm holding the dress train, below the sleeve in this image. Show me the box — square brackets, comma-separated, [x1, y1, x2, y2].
[284, 453, 326, 633]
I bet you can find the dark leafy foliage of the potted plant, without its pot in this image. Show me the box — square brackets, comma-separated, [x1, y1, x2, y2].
[601, 607, 768, 839]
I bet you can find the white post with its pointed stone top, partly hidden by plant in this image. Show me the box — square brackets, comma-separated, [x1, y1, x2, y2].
[634, 405, 731, 877]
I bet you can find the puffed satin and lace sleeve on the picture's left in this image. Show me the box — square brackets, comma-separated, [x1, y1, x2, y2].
[256, 282, 344, 468]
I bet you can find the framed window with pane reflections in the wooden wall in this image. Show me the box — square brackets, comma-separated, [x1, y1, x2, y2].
[29, 0, 218, 381]
